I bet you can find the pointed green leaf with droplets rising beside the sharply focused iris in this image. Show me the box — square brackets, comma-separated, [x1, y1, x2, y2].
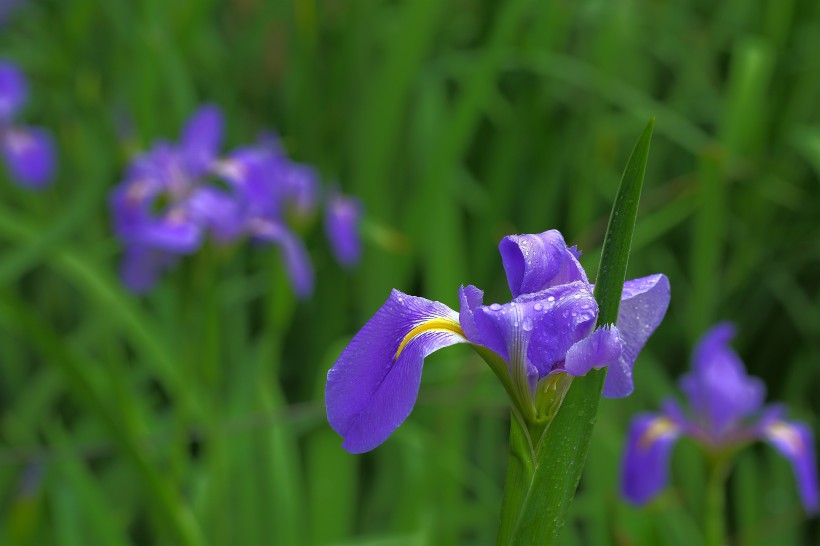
[497, 118, 655, 545]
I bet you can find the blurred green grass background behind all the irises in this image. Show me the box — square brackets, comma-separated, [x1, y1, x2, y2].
[0, 0, 820, 546]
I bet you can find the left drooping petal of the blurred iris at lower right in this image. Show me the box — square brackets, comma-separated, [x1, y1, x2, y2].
[621, 413, 680, 505]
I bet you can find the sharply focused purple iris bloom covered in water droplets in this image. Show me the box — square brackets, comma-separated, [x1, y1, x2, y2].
[325, 230, 669, 453]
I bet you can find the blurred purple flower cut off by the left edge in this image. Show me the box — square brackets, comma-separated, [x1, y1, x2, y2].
[0, 62, 55, 188]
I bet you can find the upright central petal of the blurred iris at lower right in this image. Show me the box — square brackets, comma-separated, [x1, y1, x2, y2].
[680, 323, 766, 438]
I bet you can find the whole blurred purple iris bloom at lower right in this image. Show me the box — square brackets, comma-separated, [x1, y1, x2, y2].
[622, 323, 818, 512]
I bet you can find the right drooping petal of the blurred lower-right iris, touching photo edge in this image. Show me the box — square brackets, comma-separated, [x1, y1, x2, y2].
[761, 421, 820, 513]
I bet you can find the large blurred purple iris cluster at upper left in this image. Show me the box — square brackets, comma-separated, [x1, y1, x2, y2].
[112, 105, 316, 296]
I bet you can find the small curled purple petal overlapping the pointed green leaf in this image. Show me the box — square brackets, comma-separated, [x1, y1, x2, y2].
[564, 327, 632, 386]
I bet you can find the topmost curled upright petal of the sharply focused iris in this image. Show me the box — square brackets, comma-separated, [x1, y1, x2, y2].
[498, 229, 589, 298]
